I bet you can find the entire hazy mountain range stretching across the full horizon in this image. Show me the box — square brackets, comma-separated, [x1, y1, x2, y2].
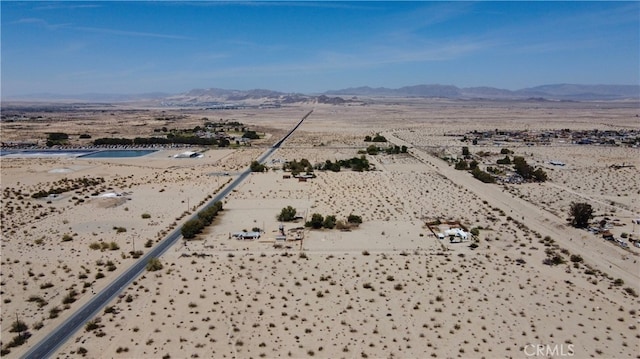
[3, 84, 640, 105]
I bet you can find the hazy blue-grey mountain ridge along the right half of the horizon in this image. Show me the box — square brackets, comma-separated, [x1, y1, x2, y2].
[325, 84, 640, 101]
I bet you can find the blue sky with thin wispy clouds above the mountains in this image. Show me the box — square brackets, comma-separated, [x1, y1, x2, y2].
[0, 1, 640, 97]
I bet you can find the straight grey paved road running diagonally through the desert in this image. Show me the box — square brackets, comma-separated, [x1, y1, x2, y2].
[22, 110, 313, 359]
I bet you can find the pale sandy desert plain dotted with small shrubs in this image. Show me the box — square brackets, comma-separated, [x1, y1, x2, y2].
[0, 99, 640, 358]
